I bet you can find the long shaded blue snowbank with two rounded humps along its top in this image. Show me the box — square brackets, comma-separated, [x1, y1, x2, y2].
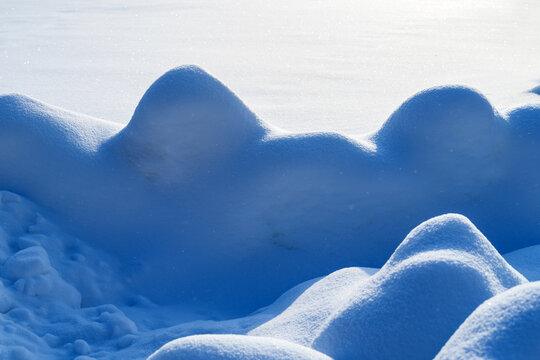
[0, 66, 540, 315]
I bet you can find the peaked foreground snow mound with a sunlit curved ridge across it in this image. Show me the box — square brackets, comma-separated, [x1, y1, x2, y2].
[254, 214, 526, 359]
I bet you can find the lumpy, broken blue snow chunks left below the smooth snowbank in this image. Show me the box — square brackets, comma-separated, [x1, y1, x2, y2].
[0, 191, 137, 359]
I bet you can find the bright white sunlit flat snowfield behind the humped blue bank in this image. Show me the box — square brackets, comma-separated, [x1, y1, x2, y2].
[0, 0, 540, 135]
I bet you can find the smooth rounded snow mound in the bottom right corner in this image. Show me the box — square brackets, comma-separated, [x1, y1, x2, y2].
[435, 282, 540, 360]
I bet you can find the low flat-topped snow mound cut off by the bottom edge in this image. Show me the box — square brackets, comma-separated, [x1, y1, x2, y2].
[148, 335, 331, 360]
